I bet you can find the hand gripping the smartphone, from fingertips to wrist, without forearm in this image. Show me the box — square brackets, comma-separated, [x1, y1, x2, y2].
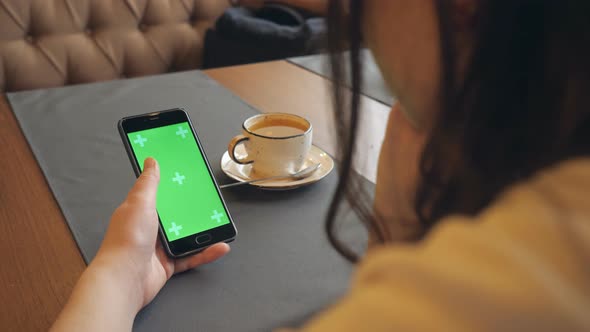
[93, 158, 230, 306]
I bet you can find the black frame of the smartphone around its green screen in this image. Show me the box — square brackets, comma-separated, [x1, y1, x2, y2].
[117, 108, 237, 258]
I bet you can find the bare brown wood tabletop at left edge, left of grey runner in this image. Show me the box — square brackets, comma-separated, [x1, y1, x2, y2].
[0, 95, 85, 331]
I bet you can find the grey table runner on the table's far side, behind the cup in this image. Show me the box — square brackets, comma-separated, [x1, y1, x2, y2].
[288, 49, 395, 105]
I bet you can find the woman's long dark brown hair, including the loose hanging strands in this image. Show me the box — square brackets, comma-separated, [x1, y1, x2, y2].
[326, 0, 590, 261]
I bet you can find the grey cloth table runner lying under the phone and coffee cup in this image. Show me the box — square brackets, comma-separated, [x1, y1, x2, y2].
[8, 72, 370, 331]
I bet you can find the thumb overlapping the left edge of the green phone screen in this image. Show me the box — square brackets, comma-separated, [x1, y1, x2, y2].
[127, 157, 160, 208]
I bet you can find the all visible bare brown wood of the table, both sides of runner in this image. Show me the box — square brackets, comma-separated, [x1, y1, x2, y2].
[0, 61, 389, 331]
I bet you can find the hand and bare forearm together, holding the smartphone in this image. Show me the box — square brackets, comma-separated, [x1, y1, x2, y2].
[53, 158, 230, 331]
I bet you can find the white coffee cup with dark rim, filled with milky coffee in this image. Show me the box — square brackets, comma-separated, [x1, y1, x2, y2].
[227, 113, 313, 177]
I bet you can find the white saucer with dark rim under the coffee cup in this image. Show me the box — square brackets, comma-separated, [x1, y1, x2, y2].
[221, 145, 334, 190]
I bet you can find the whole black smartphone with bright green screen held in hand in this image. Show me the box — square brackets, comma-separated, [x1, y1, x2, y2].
[118, 108, 237, 258]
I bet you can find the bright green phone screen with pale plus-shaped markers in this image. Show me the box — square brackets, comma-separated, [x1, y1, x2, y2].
[127, 122, 229, 241]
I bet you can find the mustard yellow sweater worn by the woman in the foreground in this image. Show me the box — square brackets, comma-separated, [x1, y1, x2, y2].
[303, 159, 590, 332]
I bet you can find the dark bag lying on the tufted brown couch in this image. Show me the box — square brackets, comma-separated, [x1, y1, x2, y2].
[203, 4, 326, 68]
